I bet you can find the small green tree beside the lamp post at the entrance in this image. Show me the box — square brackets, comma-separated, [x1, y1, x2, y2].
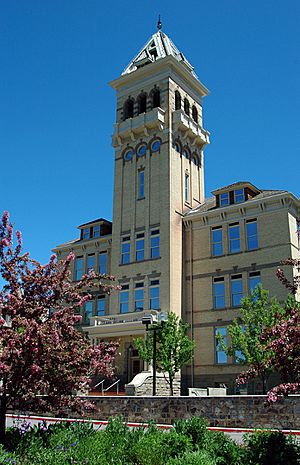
[134, 312, 195, 395]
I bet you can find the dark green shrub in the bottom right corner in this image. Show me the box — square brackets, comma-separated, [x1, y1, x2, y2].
[244, 431, 300, 465]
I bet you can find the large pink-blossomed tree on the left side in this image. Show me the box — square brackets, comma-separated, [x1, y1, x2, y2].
[0, 212, 118, 442]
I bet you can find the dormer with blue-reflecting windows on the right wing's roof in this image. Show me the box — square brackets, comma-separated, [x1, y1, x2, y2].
[212, 181, 261, 208]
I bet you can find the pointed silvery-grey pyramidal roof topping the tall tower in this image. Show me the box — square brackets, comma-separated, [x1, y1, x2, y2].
[122, 27, 198, 79]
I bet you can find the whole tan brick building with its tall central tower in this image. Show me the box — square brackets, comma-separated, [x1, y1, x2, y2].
[54, 23, 300, 390]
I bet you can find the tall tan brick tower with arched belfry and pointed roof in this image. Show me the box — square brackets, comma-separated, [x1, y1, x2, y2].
[110, 22, 209, 315]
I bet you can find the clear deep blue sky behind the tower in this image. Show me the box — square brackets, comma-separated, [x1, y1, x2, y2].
[0, 0, 300, 262]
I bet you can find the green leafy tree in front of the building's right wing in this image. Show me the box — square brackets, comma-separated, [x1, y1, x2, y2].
[218, 285, 282, 394]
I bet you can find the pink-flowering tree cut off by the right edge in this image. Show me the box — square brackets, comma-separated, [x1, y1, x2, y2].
[238, 259, 300, 402]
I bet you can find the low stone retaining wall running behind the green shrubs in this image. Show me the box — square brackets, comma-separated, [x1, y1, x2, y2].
[80, 396, 300, 429]
